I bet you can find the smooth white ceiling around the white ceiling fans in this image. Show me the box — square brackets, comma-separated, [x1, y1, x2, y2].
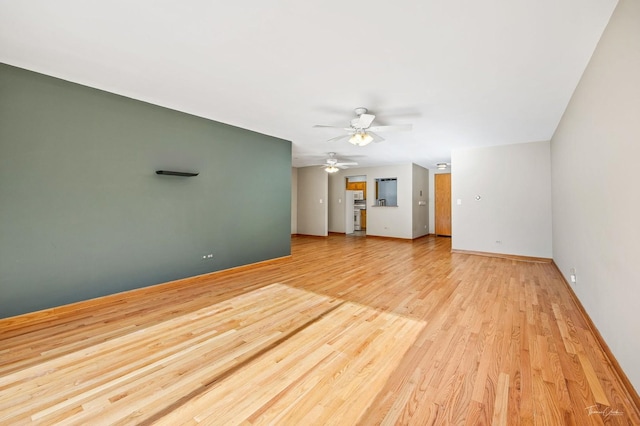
[0, 0, 617, 168]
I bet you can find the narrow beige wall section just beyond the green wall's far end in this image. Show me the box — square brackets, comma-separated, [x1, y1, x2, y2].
[297, 166, 328, 236]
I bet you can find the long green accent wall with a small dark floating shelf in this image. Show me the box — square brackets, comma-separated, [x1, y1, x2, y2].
[0, 64, 291, 317]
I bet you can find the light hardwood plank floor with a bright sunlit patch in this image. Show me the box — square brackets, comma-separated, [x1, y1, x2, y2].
[0, 235, 640, 425]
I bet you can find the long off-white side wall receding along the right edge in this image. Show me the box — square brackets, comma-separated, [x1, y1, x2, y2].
[551, 0, 640, 390]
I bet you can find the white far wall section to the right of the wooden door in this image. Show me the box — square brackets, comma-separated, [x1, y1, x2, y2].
[451, 142, 552, 258]
